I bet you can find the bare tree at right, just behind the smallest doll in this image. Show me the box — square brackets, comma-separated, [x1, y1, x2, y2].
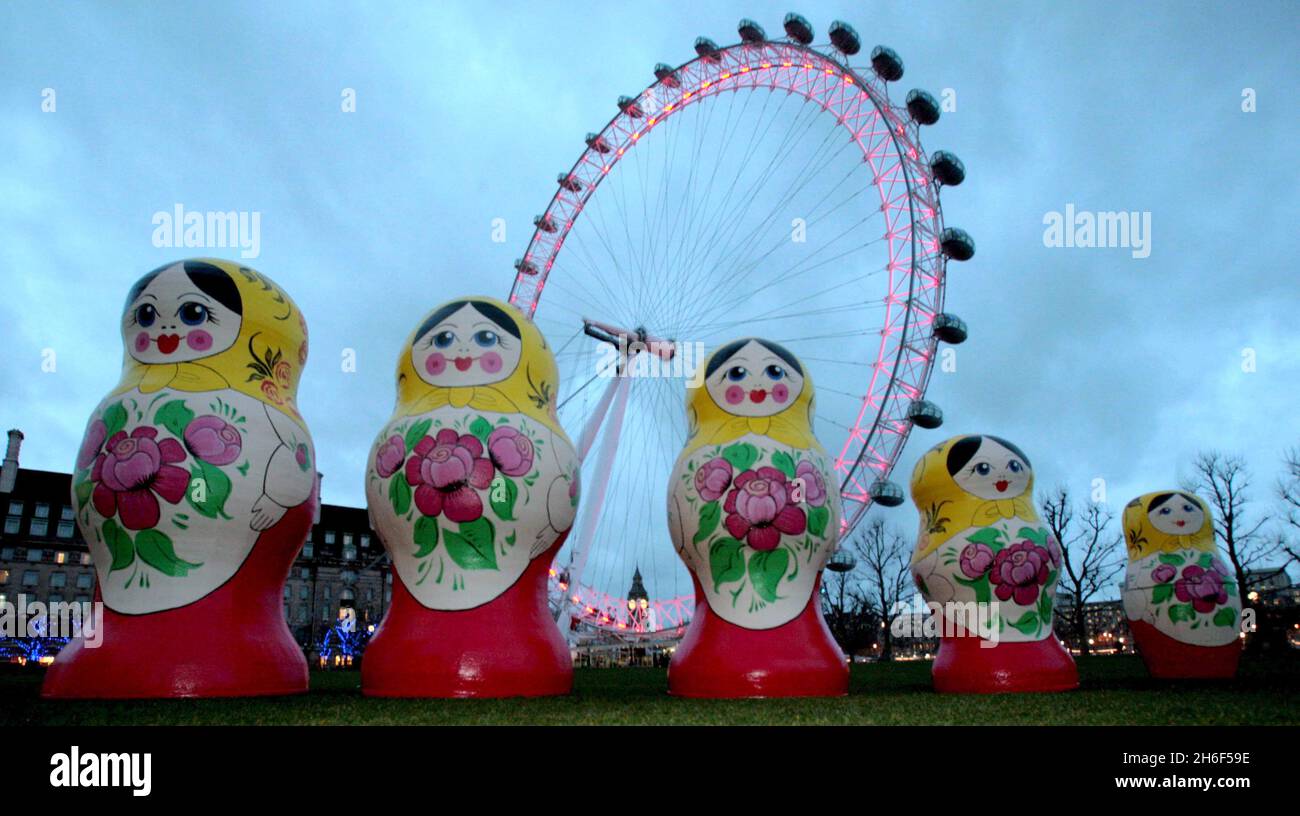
[1183, 451, 1286, 607]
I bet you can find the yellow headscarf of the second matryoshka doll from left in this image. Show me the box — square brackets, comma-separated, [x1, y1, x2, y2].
[393, 295, 564, 434]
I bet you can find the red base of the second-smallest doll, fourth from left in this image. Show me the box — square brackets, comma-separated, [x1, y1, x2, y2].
[933, 623, 1079, 694]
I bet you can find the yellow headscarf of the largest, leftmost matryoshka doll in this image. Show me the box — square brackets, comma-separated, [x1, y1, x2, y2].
[113, 257, 307, 427]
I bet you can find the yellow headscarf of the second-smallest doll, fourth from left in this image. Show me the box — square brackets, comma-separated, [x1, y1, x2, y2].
[911, 434, 1039, 560]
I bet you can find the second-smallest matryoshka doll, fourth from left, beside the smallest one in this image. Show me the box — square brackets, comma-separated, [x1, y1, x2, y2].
[911, 435, 1079, 693]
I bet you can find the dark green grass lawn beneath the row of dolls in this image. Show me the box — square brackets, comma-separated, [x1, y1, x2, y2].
[0, 654, 1300, 725]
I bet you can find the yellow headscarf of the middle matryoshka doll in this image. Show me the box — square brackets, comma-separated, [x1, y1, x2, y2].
[684, 338, 822, 455]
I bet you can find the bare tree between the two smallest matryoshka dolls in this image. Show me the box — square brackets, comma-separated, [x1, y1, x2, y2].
[1039, 485, 1125, 655]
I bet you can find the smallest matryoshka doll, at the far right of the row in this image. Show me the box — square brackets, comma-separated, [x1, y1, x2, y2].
[1123, 490, 1242, 680]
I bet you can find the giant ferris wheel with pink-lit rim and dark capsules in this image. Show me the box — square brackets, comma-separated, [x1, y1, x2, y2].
[510, 13, 975, 638]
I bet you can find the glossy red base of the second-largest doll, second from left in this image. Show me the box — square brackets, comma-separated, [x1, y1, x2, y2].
[361, 539, 573, 698]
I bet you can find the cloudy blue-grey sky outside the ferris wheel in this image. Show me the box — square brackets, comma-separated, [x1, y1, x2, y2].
[0, 0, 1300, 594]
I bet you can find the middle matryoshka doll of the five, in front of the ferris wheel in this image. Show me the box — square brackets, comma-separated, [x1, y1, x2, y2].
[668, 338, 849, 698]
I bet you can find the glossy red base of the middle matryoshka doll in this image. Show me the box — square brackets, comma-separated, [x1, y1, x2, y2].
[668, 578, 849, 698]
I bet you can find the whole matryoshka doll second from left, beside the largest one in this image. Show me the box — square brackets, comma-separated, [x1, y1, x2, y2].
[361, 298, 579, 696]
